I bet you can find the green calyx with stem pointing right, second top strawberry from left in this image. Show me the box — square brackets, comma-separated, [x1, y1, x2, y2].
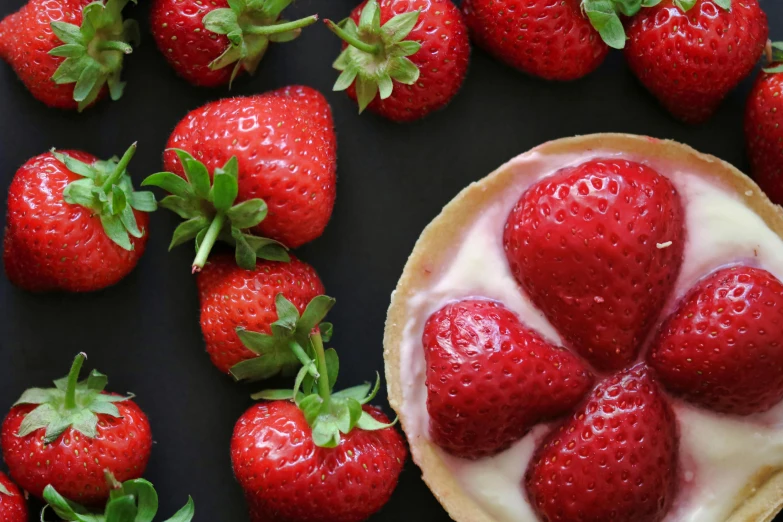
[203, 0, 318, 82]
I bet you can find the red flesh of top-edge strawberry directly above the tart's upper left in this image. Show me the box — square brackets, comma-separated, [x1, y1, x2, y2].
[462, 0, 609, 81]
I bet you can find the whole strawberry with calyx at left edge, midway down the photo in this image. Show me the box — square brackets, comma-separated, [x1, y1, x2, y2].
[3, 144, 156, 292]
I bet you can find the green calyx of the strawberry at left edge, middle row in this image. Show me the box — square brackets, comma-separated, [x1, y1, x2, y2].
[57, 143, 157, 250]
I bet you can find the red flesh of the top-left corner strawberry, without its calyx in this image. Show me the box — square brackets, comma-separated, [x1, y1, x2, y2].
[0, 0, 106, 110]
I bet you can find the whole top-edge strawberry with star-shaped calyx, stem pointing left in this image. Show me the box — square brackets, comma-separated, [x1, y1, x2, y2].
[326, 0, 470, 122]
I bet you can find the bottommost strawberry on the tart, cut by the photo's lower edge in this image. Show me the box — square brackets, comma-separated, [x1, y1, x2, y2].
[525, 365, 678, 522]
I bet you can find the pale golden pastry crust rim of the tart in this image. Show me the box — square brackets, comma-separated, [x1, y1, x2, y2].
[384, 134, 783, 522]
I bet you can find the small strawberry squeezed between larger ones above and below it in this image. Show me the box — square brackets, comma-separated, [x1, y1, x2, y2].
[197, 254, 324, 374]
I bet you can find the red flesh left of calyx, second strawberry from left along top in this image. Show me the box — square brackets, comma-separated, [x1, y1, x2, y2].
[150, 0, 233, 87]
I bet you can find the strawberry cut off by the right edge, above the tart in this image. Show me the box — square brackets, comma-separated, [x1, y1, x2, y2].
[745, 42, 783, 204]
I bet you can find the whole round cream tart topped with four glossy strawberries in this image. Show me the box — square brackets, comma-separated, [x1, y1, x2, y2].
[384, 134, 783, 522]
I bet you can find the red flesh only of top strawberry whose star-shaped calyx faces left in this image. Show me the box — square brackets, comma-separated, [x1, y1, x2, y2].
[343, 0, 470, 123]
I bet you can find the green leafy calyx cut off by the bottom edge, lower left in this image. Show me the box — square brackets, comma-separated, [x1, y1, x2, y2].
[41, 470, 195, 522]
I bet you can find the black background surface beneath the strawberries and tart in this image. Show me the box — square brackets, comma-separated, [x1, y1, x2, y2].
[0, 0, 783, 522]
